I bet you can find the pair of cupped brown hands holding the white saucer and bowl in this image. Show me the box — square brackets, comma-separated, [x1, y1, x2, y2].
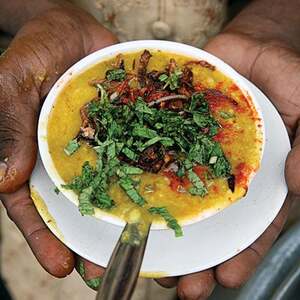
[0, 4, 300, 299]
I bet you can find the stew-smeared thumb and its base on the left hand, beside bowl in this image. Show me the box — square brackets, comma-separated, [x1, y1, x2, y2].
[0, 7, 116, 193]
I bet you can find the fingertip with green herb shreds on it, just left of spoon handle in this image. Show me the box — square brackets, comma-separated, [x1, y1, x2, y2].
[76, 256, 105, 290]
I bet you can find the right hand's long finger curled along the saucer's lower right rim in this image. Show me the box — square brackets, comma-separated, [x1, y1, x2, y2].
[215, 195, 292, 288]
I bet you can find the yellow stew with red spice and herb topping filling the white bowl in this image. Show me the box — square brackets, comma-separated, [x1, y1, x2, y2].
[47, 50, 262, 236]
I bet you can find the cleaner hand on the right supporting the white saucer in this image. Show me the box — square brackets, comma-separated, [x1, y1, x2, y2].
[154, 26, 300, 300]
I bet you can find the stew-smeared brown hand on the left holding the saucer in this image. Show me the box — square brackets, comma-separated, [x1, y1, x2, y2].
[0, 5, 117, 277]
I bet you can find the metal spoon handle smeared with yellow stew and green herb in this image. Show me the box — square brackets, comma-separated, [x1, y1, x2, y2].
[96, 223, 150, 300]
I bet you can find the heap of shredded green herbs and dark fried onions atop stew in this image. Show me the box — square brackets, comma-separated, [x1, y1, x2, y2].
[64, 54, 231, 236]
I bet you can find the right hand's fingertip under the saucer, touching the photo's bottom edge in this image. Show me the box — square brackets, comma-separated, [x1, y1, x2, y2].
[177, 269, 216, 300]
